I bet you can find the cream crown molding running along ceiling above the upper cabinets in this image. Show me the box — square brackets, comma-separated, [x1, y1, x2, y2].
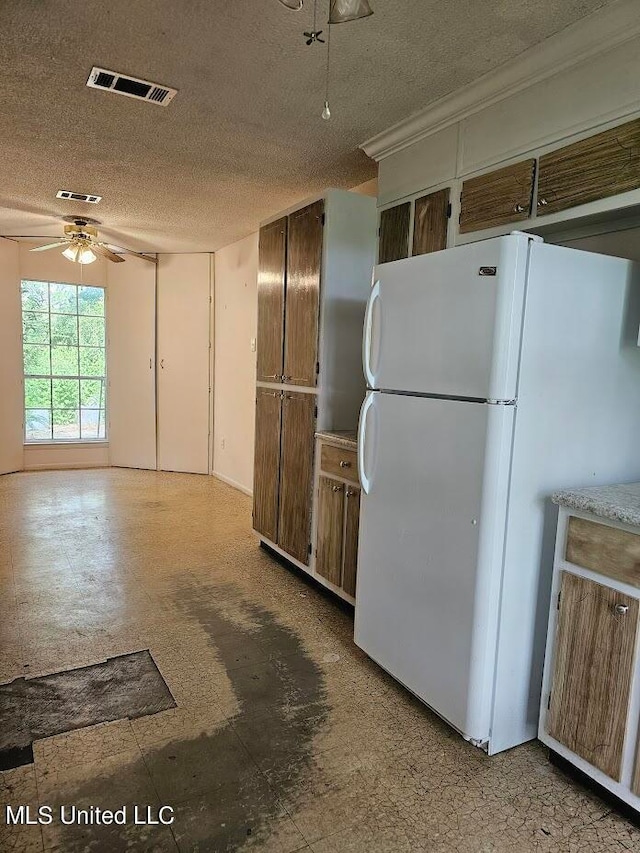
[360, 0, 640, 161]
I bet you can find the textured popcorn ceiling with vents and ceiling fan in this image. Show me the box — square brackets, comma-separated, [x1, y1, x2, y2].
[0, 0, 607, 252]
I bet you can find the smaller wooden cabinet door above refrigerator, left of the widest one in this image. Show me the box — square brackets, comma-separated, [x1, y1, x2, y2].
[460, 159, 536, 234]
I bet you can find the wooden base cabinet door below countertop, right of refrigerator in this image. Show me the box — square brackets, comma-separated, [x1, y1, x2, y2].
[547, 572, 638, 781]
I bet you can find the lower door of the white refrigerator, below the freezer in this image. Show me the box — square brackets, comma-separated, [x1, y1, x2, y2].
[355, 392, 515, 744]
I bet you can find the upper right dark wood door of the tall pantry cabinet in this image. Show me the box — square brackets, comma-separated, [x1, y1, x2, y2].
[283, 201, 324, 385]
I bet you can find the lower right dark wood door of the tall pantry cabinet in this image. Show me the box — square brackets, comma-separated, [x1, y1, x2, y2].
[278, 391, 316, 565]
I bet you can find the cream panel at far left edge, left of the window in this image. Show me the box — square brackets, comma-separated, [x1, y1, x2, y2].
[0, 238, 24, 474]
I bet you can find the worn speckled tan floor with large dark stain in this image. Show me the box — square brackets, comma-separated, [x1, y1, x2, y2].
[0, 469, 640, 853]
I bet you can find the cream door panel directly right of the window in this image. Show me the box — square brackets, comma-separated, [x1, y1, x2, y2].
[107, 255, 156, 469]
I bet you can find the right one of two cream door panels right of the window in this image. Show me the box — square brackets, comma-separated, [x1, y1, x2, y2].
[158, 254, 210, 474]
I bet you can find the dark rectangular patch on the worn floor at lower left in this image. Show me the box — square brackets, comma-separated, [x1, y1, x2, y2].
[0, 649, 176, 770]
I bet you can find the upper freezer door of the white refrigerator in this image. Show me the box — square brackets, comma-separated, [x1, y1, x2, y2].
[363, 234, 530, 400]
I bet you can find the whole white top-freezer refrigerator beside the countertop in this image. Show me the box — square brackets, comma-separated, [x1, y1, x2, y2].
[355, 233, 640, 754]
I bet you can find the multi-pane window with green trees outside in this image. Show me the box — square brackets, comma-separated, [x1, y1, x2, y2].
[22, 281, 106, 443]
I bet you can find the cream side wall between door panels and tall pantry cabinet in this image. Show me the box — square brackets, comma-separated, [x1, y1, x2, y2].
[213, 234, 258, 493]
